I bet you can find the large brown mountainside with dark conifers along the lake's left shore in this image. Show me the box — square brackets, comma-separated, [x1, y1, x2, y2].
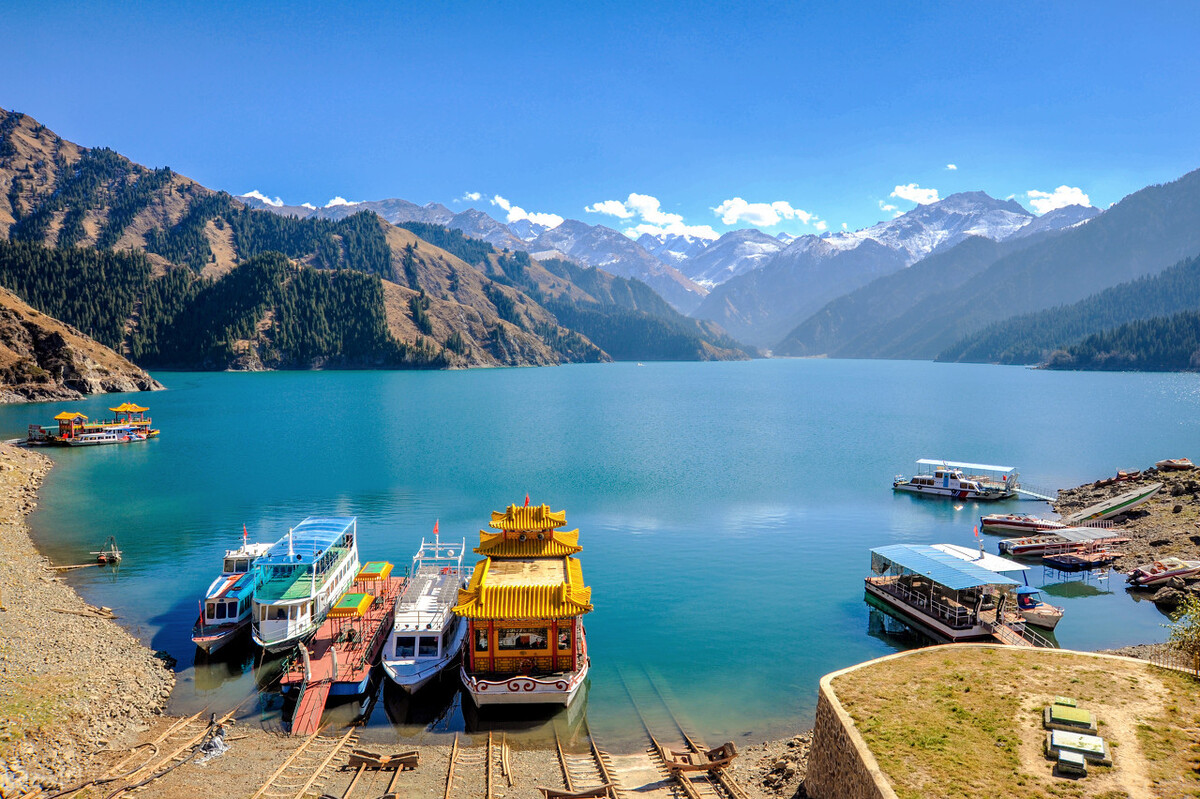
[0, 110, 745, 368]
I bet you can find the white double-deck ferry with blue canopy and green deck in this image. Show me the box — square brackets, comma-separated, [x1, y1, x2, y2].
[252, 516, 359, 653]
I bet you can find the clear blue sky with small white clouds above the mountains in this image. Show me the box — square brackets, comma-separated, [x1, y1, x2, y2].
[0, 2, 1200, 234]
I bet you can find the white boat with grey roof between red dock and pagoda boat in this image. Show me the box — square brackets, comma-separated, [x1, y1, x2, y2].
[383, 523, 470, 693]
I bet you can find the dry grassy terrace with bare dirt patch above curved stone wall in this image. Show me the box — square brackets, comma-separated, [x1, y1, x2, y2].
[833, 647, 1200, 799]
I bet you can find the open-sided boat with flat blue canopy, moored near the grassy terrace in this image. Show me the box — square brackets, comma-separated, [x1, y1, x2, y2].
[866, 543, 1028, 644]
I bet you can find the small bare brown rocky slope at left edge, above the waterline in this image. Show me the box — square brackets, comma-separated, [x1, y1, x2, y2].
[0, 288, 162, 402]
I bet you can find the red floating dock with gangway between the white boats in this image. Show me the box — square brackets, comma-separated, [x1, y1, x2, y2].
[280, 561, 404, 735]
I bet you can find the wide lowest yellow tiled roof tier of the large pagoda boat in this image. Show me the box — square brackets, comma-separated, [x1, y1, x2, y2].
[454, 558, 592, 620]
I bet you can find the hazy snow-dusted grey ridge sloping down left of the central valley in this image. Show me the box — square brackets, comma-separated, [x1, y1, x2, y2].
[527, 220, 707, 313]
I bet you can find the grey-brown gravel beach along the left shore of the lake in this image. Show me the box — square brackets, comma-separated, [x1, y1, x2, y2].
[0, 444, 174, 797]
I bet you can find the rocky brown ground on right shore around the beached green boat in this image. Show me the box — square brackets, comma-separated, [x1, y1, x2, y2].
[1054, 460, 1200, 572]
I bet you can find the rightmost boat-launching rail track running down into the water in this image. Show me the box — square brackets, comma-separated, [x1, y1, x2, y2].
[616, 669, 746, 799]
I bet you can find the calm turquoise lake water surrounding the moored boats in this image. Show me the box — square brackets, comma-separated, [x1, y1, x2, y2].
[0, 360, 1200, 740]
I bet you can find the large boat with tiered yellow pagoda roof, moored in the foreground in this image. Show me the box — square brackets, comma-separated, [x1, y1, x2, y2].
[454, 497, 592, 707]
